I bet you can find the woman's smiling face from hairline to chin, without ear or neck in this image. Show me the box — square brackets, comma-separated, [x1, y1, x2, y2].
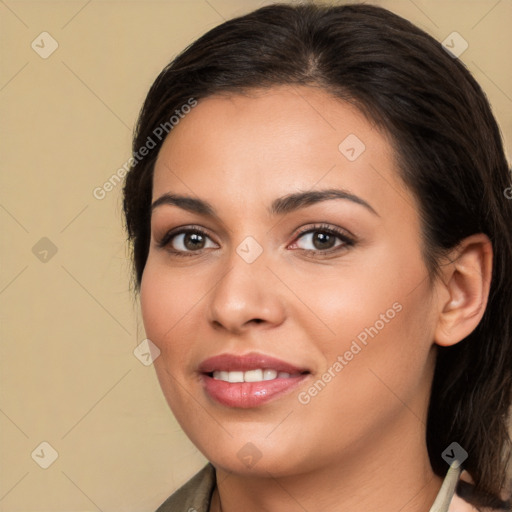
[140, 86, 436, 475]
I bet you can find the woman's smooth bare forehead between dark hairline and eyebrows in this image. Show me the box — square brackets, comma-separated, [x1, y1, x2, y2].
[153, 86, 405, 216]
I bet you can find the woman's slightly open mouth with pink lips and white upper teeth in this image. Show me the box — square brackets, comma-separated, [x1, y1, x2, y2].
[198, 353, 311, 409]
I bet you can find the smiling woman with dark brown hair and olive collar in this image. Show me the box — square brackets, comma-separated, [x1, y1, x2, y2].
[124, 4, 512, 512]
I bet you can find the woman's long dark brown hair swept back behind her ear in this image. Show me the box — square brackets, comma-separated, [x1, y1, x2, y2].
[124, 4, 512, 507]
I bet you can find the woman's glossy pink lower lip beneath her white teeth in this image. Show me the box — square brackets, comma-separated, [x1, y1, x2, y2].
[202, 374, 309, 409]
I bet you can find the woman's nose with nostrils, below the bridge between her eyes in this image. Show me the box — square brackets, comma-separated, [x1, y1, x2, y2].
[208, 252, 286, 334]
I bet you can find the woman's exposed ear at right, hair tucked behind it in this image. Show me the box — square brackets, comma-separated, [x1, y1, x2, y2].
[434, 233, 493, 347]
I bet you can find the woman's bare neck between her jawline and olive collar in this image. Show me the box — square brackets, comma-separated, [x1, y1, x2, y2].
[210, 412, 442, 512]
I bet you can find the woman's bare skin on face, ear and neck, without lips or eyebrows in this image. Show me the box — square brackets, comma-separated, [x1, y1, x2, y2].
[140, 86, 492, 512]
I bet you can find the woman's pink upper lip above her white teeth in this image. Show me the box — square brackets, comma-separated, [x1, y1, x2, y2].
[199, 352, 309, 374]
